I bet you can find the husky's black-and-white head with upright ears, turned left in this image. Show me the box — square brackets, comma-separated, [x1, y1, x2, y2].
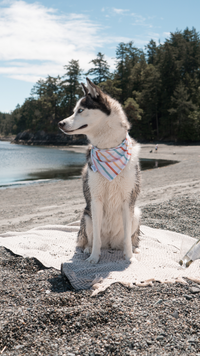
[58, 78, 111, 135]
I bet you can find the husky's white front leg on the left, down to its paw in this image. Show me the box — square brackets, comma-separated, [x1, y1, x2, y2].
[87, 199, 103, 263]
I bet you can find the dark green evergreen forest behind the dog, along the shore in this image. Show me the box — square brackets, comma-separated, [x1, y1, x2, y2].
[0, 28, 200, 142]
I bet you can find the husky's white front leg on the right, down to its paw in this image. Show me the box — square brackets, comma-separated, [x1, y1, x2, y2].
[122, 201, 133, 261]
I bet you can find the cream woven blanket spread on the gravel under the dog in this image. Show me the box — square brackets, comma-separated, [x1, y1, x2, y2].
[0, 222, 200, 295]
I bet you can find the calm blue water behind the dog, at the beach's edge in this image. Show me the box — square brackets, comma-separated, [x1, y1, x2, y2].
[0, 141, 176, 188]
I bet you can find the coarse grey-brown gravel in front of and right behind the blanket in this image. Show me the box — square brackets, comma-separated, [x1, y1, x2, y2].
[0, 196, 200, 356]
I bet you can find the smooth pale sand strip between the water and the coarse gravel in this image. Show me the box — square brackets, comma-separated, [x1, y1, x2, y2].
[0, 144, 200, 232]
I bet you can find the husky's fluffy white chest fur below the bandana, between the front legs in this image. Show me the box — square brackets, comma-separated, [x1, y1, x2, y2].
[87, 144, 139, 247]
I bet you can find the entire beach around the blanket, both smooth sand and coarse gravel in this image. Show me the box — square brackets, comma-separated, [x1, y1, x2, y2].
[0, 144, 200, 356]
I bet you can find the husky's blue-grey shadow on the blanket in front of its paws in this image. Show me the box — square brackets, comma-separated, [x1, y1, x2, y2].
[61, 247, 131, 290]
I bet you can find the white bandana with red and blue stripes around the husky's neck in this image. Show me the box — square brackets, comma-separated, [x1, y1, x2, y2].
[91, 133, 132, 181]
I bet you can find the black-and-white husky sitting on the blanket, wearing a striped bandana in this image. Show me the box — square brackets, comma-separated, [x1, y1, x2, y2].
[58, 78, 140, 263]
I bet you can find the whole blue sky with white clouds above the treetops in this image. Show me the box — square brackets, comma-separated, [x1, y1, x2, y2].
[0, 0, 200, 112]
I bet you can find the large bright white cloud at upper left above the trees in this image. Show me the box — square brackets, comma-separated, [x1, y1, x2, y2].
[0, 0, 129, 82]
